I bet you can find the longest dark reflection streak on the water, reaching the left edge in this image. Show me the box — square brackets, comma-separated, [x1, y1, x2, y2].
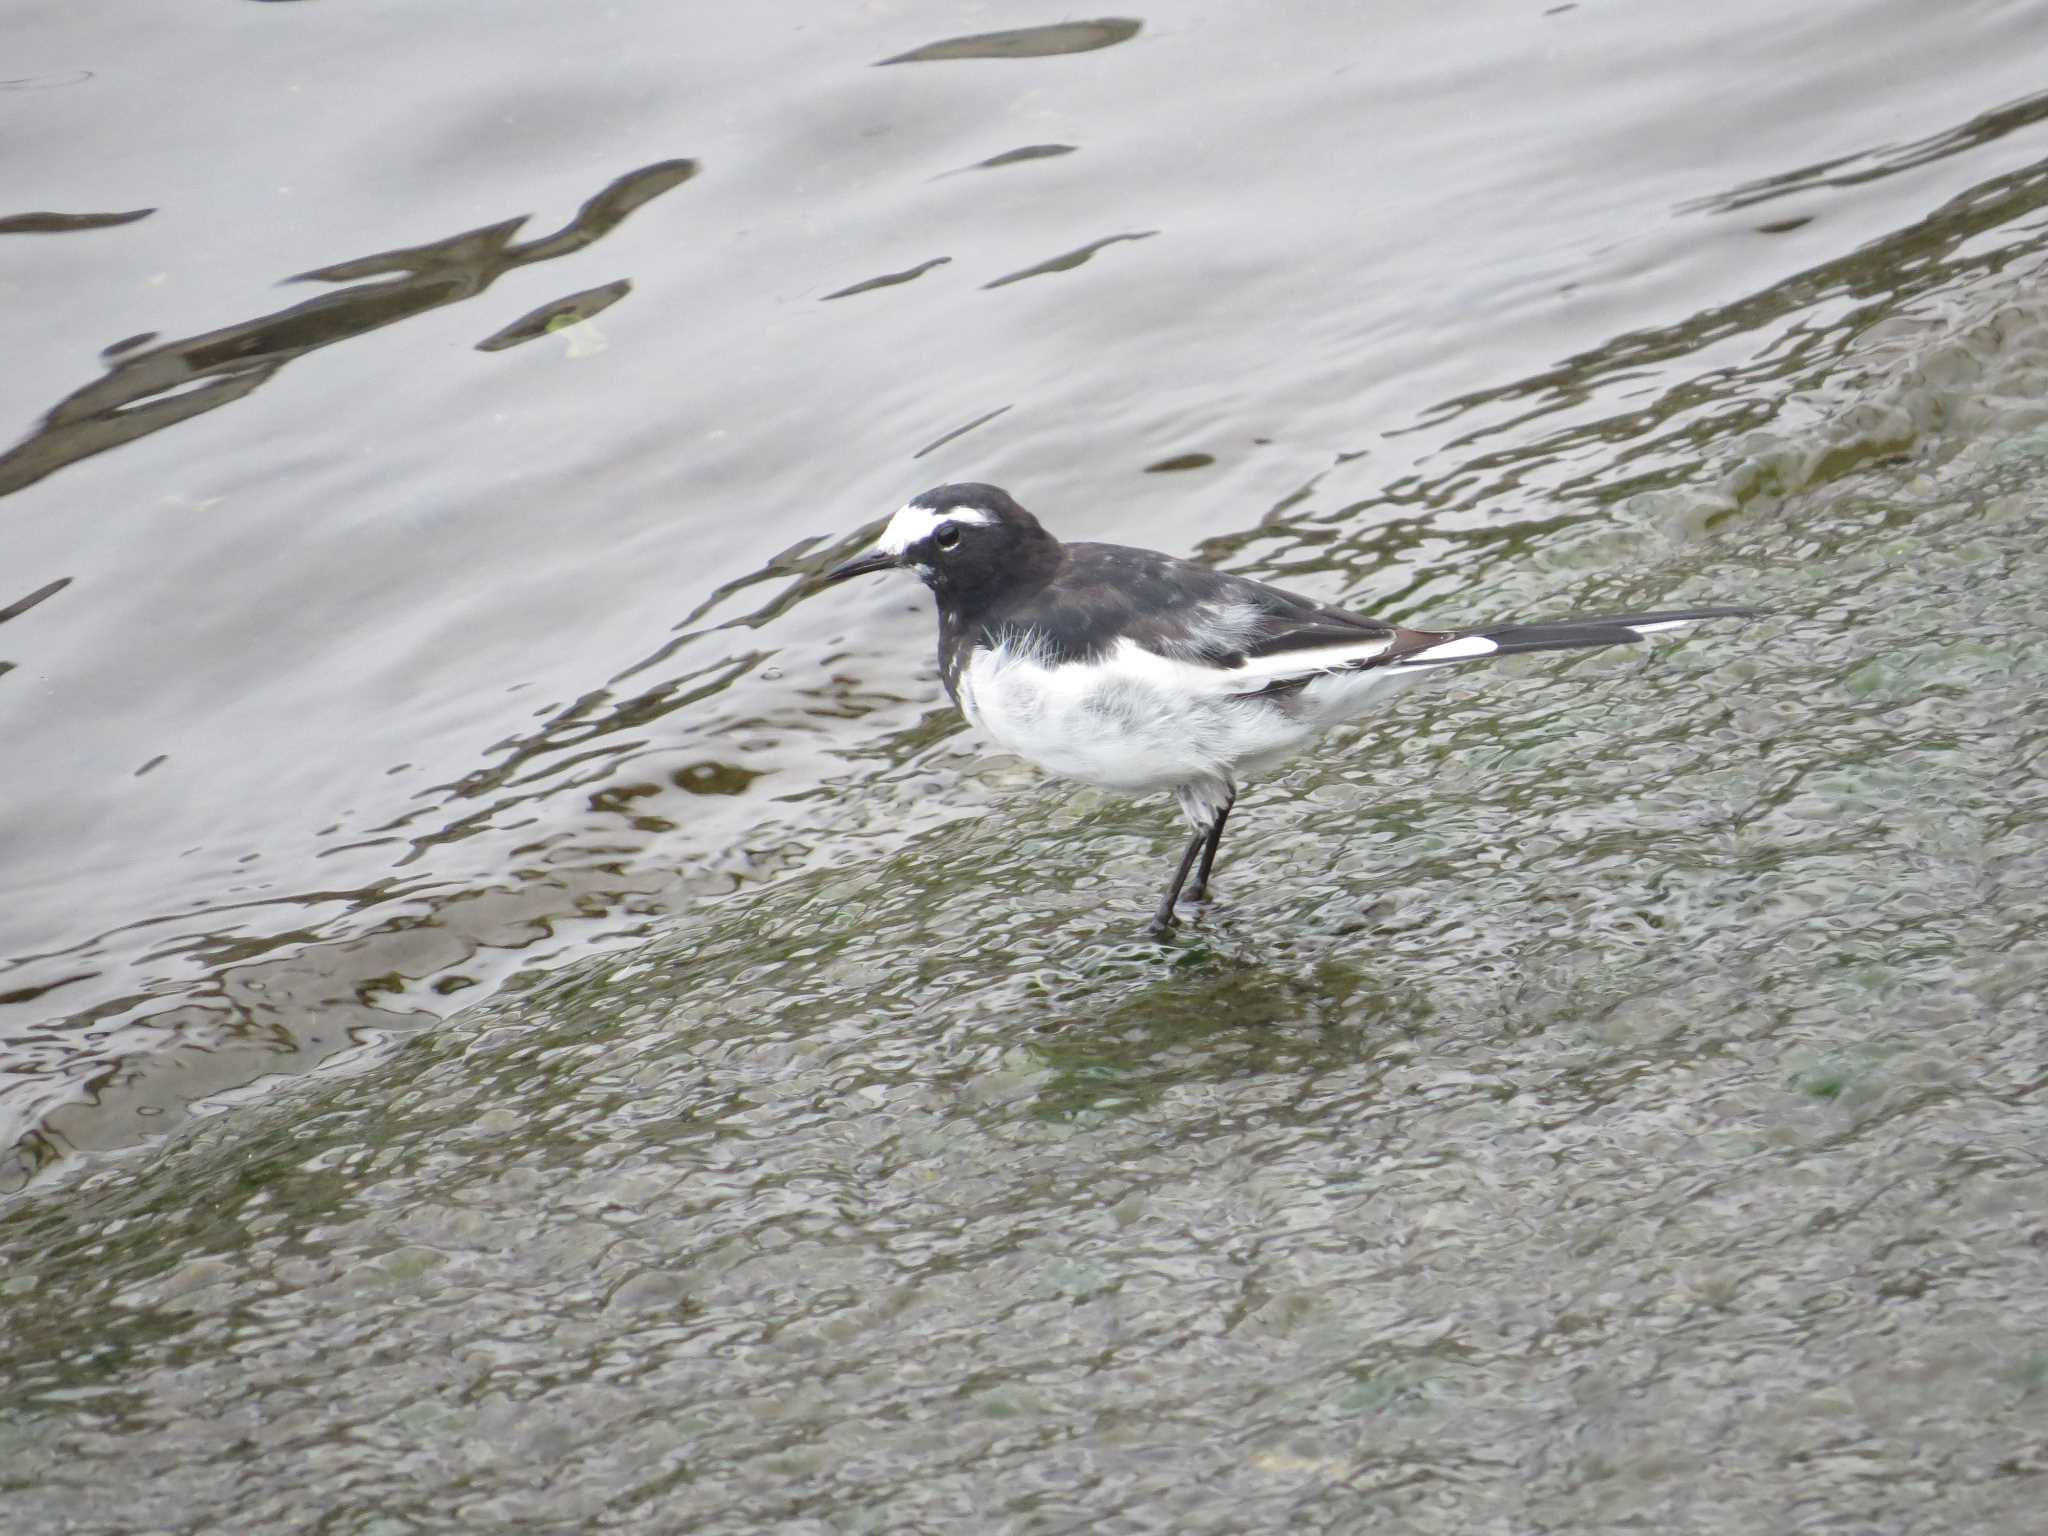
[0, 160, 696, 496]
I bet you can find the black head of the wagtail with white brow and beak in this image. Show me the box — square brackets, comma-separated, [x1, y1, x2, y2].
[825, 483, 1059, 608]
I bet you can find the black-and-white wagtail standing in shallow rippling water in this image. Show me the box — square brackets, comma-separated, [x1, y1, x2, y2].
[825, 483, 1751, 934]
